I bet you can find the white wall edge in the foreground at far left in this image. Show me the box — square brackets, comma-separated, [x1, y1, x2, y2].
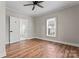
[0, 2, 6, 57]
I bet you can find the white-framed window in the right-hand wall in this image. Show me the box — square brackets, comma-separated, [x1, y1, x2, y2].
[47, 17, 56, 37]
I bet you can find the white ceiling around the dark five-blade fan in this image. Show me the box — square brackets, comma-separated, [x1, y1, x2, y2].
[6, 1, 79, 16]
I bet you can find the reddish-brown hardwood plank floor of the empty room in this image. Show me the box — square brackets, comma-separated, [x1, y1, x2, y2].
[6, 39, 79, 58]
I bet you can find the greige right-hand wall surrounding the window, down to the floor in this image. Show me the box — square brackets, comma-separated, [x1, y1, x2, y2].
[34, 6, 79, 46]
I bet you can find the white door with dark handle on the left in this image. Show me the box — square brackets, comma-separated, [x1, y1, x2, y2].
[10, 16, 20, 43]
